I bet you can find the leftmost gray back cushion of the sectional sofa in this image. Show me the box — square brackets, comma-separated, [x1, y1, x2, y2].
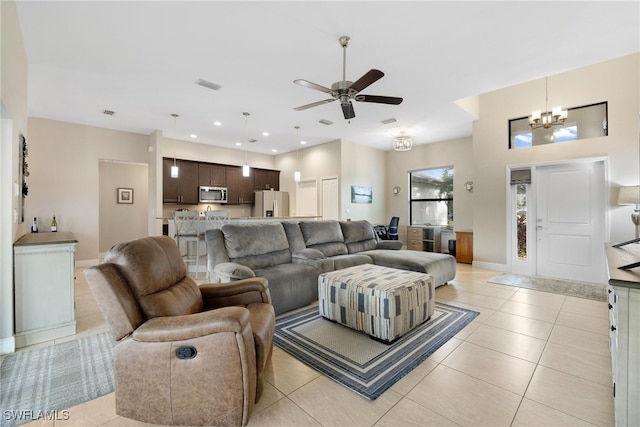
[222, 222, 291, 270]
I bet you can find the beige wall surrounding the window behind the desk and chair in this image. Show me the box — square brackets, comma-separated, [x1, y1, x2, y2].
[385, 138, 475, 241]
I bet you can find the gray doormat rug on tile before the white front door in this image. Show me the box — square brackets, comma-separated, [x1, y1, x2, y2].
[488, 273, 607, 301]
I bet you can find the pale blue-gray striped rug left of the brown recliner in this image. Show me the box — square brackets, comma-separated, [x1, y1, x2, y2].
[0, 332, 115, 427]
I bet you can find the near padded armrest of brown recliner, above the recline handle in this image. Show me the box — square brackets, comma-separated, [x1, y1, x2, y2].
[131, 307, 249, 342]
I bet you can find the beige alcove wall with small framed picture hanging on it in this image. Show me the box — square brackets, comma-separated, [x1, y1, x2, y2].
[98, 160, 149, 253]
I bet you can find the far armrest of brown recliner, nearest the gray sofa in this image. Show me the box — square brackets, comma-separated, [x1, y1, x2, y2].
[199, 277, 271, 310]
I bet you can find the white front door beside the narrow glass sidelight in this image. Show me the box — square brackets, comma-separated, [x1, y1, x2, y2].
[535, 162, 605, 283]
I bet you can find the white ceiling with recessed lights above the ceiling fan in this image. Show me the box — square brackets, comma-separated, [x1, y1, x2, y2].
[17, 0, 640, 154]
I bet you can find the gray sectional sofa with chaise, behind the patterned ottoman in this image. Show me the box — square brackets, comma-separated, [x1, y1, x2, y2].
[205, 220, 456, 314]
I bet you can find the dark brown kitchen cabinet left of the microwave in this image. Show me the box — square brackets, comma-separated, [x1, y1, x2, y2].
[162, 158, 198, 205]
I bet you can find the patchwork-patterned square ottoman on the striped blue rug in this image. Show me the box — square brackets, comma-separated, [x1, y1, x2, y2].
[318, 264, 435, 343]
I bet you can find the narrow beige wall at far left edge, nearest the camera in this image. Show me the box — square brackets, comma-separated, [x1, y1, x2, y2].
[0, 1, 29, 353]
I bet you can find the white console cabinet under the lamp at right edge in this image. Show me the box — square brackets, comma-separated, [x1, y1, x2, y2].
[605, 244, 640, 427]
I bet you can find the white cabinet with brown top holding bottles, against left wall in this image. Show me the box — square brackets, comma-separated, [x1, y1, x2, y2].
[13, 232, 78, 347]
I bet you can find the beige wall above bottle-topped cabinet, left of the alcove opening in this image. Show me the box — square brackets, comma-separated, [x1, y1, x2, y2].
[25, 118, 149, 261]
